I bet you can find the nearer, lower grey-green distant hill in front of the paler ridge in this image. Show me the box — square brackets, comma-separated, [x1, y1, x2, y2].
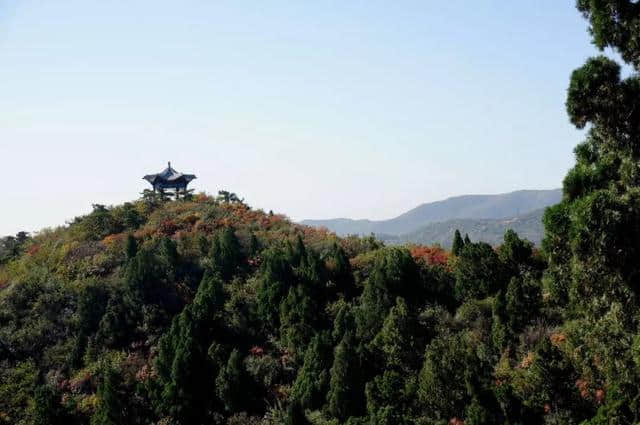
[377, 209, 544, 248]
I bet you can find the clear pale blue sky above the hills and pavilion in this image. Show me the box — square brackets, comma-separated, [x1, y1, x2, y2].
[0, 0, 608, 235]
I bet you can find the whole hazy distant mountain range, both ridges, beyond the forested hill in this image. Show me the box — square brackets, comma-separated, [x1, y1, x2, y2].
[302, 189, 562, 247]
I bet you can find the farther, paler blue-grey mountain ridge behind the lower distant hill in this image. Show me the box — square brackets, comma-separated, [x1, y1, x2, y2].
[302, 189, 562, 240]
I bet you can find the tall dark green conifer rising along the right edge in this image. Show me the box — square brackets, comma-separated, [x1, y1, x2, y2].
[543, 0, 640, 423]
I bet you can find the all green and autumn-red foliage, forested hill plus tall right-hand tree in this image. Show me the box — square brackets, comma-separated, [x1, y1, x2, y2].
[0, 0, 640, 425]
